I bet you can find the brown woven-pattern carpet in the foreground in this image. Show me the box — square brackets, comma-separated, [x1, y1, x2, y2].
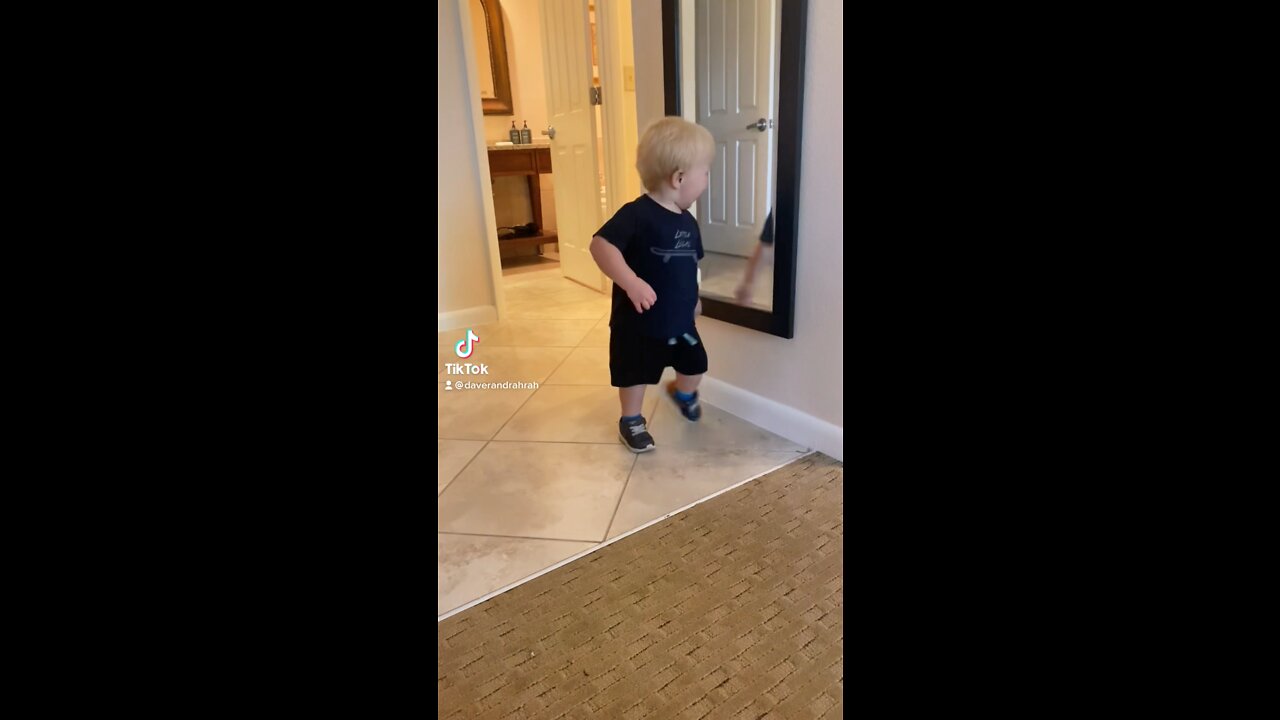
[435, 454, 845, 720]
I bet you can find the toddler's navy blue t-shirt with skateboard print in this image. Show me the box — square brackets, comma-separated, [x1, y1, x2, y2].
[595, 195, 703, 338]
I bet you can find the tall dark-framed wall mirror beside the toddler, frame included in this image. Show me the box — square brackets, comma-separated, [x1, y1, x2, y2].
[662, 0, 808, 338]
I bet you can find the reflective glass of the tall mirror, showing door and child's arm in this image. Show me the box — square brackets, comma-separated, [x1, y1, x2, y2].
[681, 0, 780, 311]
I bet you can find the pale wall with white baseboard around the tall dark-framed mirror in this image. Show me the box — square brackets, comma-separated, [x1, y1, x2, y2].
[634, 0, 845, 460]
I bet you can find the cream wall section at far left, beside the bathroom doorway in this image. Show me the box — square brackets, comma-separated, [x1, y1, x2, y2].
[435, 0, 500, 331]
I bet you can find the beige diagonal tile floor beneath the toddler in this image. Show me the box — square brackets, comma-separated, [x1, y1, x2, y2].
[436, 266, 808, 615]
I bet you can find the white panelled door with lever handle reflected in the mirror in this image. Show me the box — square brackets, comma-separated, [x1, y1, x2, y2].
[694, 0, 778, 256]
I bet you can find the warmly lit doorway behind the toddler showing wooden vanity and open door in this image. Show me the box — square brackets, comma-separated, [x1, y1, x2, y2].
[467, 0, 639, 295]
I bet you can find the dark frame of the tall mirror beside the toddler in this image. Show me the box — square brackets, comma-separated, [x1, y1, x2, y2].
[662, 0, 809, 338]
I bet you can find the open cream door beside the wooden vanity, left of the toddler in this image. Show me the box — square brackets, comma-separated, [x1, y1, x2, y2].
[540, 0, 605, 292]
